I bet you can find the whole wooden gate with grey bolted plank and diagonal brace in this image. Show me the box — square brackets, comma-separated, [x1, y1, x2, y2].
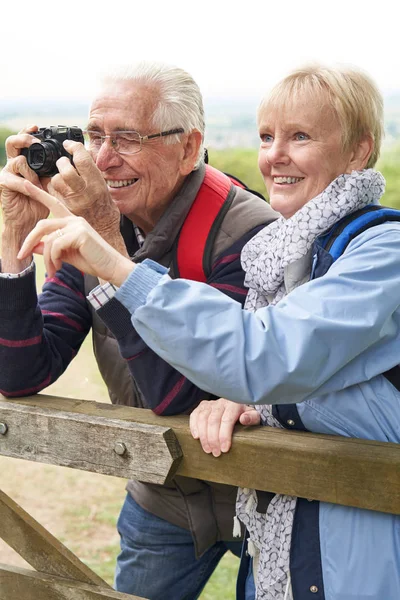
[0, 395, 400, 600]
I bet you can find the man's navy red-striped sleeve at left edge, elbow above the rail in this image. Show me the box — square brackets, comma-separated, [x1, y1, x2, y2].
[0, 264, 91, 397]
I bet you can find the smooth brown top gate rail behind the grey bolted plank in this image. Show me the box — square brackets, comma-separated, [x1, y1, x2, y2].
[0, 395, 400, 514]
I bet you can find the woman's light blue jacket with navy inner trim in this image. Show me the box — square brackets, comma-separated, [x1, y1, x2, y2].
[113, 223, 400, 600]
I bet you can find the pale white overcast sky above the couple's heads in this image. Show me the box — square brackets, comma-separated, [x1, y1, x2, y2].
[0, 0, 400, 100]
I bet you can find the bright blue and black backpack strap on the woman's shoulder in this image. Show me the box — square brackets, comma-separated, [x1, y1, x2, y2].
[318, 204, 400, 391]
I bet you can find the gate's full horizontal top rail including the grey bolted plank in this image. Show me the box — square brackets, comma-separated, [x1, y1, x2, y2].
[0, 395, 400, 514]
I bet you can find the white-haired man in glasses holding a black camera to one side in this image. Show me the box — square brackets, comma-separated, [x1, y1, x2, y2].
[0, 63, 275, 600]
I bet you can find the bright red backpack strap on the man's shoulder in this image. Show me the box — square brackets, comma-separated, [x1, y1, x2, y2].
[174, 165, 233, 282]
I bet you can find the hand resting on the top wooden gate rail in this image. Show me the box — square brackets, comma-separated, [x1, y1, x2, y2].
[190, 398, 260, 456]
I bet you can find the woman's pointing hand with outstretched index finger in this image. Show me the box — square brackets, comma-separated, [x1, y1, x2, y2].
[0, 175, 135, 286]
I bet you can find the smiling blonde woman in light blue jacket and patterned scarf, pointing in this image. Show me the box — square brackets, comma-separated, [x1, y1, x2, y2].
[3, 67, 400, 600]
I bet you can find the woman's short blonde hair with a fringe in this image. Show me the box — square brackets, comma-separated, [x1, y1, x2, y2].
[257, 65, 384, 168]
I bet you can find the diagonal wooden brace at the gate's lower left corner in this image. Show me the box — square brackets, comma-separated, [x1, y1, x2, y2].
[0, 490, 110, 588]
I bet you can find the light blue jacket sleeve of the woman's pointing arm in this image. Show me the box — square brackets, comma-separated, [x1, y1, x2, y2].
[117, 223, 400, 404]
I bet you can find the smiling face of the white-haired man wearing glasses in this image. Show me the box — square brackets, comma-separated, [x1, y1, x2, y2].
[87, 81, 184, 232]
